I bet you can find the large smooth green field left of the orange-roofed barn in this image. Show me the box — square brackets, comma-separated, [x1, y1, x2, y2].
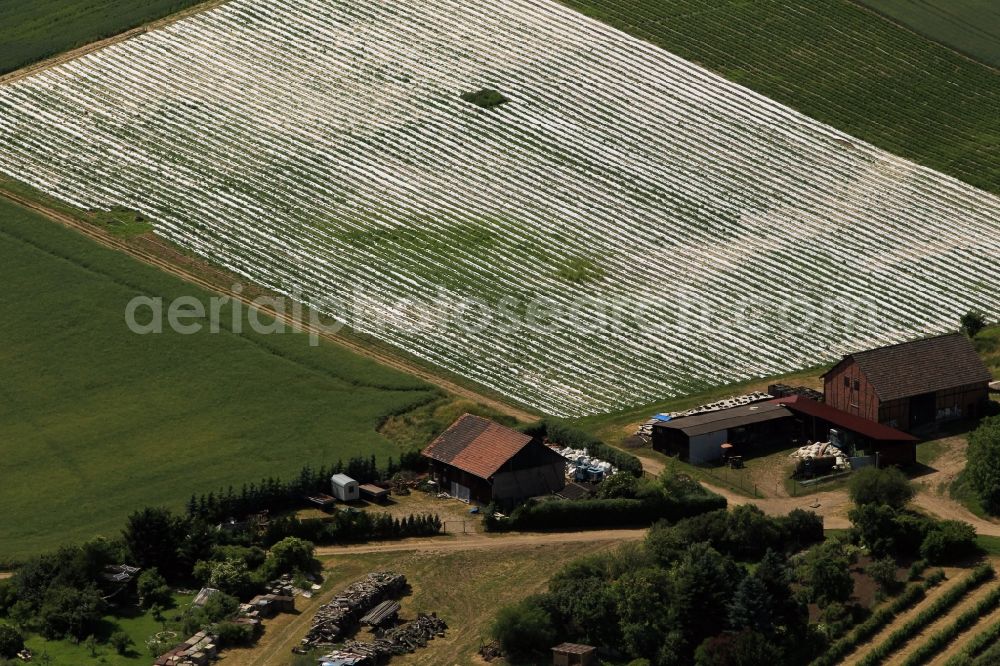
[0, 201, 437, 560]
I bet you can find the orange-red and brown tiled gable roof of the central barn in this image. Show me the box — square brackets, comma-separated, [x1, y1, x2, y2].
[423, 414, 533, 479]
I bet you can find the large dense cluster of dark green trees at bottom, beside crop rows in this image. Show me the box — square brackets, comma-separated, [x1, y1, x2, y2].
[492, 500, 823, 666]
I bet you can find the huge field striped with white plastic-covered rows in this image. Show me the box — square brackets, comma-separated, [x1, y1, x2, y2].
[0, 0, 1000, 416]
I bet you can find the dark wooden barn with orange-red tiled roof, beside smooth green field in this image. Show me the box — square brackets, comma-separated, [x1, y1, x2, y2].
[423, 414, 566, 505]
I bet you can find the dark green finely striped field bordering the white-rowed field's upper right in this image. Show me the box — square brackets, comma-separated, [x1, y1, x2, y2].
[563, 0, 1000, 193]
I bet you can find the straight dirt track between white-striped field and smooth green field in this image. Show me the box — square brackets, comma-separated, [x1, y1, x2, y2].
[0, 190, 538, 422]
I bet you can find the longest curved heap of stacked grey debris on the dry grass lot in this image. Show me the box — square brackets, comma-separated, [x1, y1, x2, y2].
[302, 571, 406, 647]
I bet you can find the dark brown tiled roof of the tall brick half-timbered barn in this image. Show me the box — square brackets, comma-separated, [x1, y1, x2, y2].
[828, 333, 992, 400]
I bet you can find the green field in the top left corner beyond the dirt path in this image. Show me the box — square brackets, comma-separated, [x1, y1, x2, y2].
[0, 0, 202, 74]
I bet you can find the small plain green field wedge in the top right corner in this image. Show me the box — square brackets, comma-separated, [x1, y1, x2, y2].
[860, 0, 1000, 67]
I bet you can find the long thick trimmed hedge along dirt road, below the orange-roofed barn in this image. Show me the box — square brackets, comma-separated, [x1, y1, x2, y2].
[484, 494, 726, 531]
